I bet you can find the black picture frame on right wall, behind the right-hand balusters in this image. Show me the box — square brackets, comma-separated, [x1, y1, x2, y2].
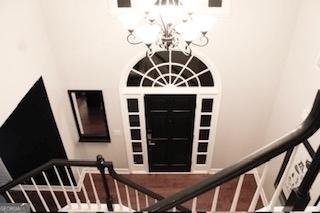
[274, 140, 320, 205]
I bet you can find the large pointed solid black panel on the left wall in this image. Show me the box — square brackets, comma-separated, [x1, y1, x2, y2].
[0, 78, 67, 178]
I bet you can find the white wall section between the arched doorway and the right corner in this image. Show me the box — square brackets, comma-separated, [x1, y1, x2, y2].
[199, 0, 299, 168]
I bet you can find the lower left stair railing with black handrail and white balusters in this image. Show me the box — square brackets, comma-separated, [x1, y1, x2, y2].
[0, 155, 190, 212]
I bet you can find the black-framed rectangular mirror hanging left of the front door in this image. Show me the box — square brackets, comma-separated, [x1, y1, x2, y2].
[68, 90, 110, 143]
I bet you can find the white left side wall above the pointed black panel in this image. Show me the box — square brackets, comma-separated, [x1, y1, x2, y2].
[0, 0, 74, 158]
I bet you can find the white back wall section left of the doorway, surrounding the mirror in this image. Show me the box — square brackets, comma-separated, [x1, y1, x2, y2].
[41, 0, 134, 168]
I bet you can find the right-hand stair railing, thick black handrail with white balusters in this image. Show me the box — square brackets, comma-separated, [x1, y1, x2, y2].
[143, 91, 320, 212]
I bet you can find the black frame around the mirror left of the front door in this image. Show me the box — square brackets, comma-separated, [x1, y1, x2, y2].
[68, 90, 111, 143]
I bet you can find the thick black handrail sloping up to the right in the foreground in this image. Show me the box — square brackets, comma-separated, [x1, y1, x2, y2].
[143, 90, 320, 212]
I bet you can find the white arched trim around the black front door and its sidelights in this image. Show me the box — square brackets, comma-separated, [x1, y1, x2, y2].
[119, 51, 222, 173]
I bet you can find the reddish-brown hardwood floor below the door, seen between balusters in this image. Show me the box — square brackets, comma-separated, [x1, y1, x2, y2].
[11, 174, 263, 212]
